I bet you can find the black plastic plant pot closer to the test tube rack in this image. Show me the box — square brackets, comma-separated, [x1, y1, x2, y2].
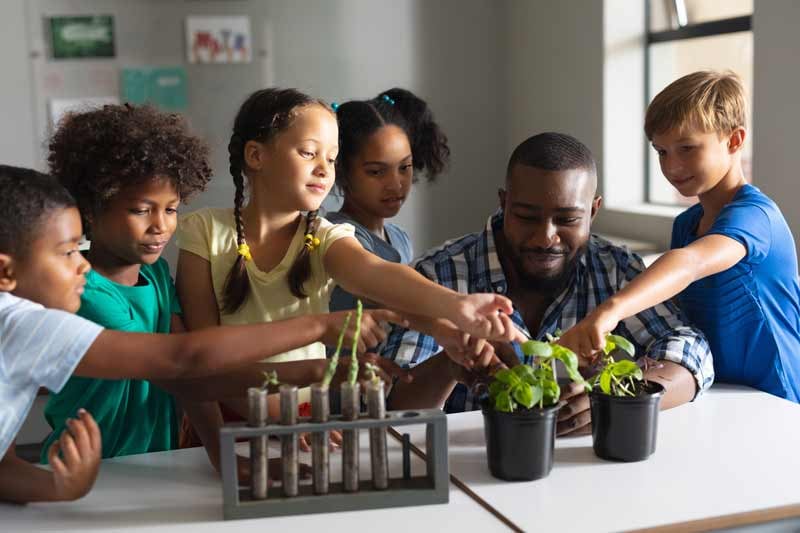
[483, 400, 561, 481]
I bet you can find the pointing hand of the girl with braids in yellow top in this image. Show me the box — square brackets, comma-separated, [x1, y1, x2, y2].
[445, 293, 528, 342]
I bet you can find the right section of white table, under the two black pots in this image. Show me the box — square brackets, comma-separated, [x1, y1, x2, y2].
[404, 386, 800, 533]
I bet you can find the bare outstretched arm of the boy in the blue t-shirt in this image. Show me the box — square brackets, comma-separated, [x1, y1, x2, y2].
[559, 235, 747, 358]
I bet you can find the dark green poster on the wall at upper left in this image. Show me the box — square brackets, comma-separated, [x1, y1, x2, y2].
[50, 15, 115, 59]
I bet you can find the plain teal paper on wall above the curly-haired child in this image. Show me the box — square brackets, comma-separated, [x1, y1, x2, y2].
[120, 67, 187, 111]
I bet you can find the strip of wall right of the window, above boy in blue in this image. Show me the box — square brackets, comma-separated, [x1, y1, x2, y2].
[753, 0, 800, 256]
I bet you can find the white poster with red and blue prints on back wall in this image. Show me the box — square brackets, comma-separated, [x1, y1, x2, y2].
[186, 16, 252, 63]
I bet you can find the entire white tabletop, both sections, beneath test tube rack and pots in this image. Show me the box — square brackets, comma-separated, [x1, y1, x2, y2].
[0, 386, 800, 533]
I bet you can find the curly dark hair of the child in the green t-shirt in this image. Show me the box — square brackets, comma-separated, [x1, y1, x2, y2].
[47, 104, 211, 230]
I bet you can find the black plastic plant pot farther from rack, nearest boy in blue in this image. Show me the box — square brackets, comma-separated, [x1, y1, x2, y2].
[589, 381, 664, 462]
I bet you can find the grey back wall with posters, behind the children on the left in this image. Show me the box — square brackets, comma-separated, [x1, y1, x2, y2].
[0, 0, 505, 259]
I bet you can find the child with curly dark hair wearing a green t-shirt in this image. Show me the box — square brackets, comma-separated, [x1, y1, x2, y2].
[42, 105, 400, 467]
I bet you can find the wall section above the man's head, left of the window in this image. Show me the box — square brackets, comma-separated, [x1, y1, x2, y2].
[502, 0, 603, 176]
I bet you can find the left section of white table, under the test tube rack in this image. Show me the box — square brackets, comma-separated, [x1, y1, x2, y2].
[0, 431, 507, 533]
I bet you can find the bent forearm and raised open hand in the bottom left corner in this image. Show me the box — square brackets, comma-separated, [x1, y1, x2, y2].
[0, 409, 102, 503]
